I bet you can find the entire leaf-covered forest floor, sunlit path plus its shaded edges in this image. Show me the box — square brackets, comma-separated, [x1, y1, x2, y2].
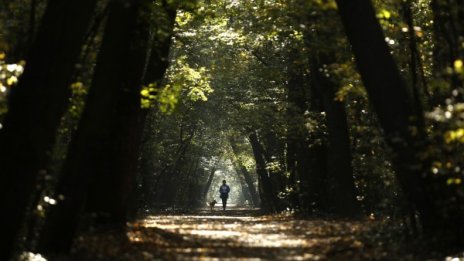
[72, 208, 464, 261]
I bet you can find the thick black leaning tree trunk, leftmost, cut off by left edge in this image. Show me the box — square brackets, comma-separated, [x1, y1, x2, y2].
[0, 0, 96, 260]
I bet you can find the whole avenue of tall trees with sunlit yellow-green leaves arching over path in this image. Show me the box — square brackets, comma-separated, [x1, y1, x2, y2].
[0, 0, 464, 260]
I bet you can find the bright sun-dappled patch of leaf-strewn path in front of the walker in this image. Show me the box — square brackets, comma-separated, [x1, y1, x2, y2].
[128, 209, 363, 260]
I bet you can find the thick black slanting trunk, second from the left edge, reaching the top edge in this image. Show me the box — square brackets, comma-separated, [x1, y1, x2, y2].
[38, 1, 143, 254]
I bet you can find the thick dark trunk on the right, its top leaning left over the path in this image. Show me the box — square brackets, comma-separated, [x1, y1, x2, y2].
[337, 0, 441, 232]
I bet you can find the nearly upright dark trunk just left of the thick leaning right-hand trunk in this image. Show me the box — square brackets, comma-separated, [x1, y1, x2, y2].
[311, 55, 360, 217]
